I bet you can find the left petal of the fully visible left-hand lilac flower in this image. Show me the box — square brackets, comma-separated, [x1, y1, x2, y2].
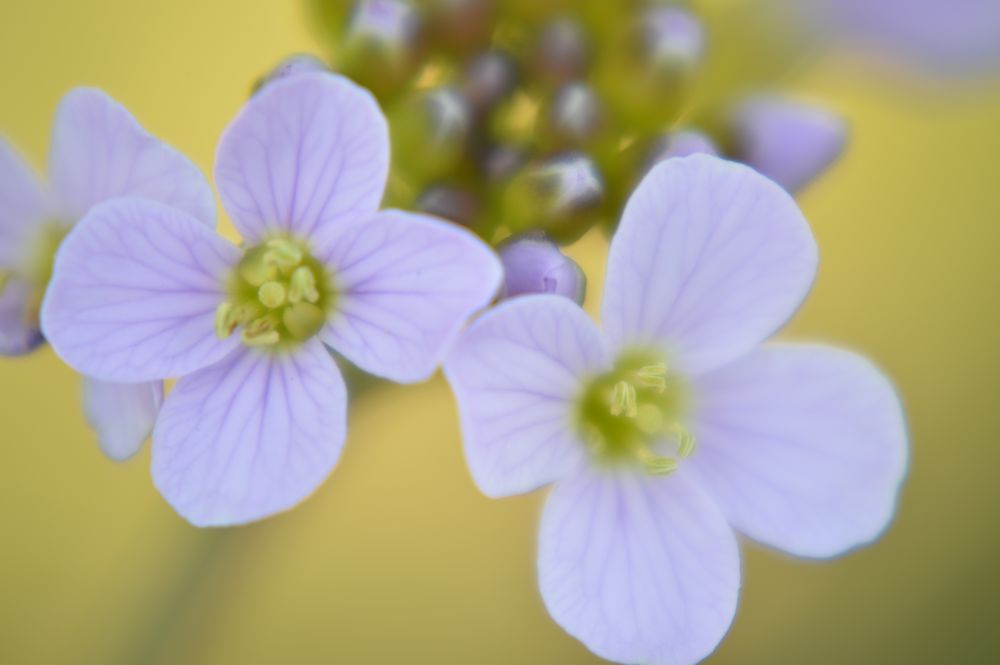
[42, 199, 240, 383]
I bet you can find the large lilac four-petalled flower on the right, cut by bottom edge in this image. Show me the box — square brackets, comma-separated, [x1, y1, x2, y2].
[445, 155, 907, 665]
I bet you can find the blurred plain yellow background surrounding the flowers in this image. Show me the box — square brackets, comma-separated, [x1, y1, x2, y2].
[0, 0, 1000, 665]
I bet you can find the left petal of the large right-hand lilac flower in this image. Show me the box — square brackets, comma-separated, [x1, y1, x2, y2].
[444, 295, 611, 497]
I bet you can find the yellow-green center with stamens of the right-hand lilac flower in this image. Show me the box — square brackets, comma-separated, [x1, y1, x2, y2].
[576, 351, 695, 475]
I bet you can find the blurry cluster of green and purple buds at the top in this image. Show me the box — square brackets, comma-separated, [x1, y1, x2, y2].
[300, 0, 845, 260]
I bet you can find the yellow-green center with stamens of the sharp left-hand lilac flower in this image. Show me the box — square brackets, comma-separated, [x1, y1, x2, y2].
[215, 236, 336, 350]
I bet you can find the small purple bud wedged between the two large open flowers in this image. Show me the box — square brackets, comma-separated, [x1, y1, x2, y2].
[498, 236, 587, 305]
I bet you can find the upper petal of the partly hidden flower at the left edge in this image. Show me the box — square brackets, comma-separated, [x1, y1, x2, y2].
[49, 88, 215, 228]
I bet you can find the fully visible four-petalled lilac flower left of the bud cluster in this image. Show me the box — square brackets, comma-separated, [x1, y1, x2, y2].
[42, 73, 500, 525]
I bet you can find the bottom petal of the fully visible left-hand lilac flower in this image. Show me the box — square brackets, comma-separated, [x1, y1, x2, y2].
[153, 340, 347, 526]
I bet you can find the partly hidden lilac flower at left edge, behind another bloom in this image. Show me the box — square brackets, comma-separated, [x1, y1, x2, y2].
[0, 88, 215, 459]
